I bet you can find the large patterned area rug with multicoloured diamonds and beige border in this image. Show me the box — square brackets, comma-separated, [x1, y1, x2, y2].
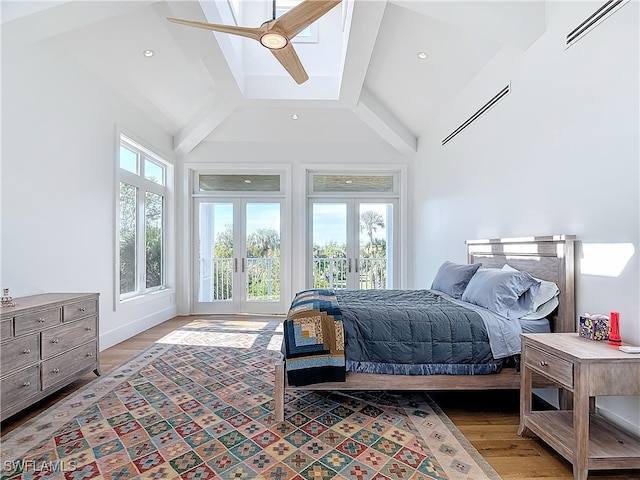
[2, 318, 500, 480]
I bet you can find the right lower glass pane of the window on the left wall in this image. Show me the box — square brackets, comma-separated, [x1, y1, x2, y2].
[144, 192, 164, 288]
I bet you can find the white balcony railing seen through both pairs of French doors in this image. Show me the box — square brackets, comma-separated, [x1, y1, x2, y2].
[200, 258, 387, 301]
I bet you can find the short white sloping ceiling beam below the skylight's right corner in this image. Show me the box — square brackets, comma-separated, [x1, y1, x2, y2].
[354, 89, 418, 155]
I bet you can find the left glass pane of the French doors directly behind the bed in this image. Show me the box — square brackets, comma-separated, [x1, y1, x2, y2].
[312, 203, 347, 289]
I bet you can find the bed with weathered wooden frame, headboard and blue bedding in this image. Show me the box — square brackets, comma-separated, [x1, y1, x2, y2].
[275, 235, 576, 420]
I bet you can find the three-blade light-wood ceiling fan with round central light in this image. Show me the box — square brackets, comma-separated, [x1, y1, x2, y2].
[167, 0, 342, 84]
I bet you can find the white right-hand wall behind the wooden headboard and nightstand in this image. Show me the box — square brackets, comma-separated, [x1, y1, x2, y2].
[414, 2, 640, 433]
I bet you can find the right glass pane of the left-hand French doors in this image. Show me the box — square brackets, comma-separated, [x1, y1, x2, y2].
[244, 203, 280, 301]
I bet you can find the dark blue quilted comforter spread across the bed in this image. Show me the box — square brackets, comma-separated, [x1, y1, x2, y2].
[335, 290, 503, 375]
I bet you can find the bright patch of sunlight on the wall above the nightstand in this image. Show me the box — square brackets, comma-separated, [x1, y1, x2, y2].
[580, 243, 635, 277]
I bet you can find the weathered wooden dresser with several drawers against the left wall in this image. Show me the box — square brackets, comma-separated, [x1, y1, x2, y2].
[0, 293, 100, 420]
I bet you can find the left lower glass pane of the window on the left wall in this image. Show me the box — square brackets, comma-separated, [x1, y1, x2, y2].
[120, 182, 138, 294]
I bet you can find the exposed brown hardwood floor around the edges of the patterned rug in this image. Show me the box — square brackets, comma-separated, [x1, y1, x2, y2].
[0, 317, 640, 480]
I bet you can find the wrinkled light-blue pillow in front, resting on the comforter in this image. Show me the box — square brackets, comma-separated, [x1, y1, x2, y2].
[462, 268, 540, 320]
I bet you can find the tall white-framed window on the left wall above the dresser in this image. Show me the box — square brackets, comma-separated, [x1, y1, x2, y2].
[118, 135, 168, 300]
